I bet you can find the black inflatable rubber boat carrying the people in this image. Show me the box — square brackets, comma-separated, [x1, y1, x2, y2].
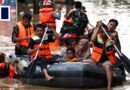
[16, 57, 126, 88]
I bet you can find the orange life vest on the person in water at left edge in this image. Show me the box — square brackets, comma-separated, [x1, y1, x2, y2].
[0, 63, 15, 78]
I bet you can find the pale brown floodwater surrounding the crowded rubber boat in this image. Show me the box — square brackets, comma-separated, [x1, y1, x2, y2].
[0, 0, 130, 90]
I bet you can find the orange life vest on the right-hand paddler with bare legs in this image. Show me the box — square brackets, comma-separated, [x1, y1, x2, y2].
[92, 34, 117, 64]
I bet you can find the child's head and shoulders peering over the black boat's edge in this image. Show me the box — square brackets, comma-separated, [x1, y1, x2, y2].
[65, 47, 79, 62]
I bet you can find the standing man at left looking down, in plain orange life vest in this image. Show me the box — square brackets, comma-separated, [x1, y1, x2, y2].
[12, 14, 34, 56]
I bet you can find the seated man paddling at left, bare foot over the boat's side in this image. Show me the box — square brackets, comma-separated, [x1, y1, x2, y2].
[28, 24, 55, 81]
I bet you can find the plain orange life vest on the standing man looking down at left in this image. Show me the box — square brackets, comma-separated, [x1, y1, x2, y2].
[17, 21, 34, 47]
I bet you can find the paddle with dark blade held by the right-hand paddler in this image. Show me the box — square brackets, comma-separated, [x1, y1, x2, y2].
[101, 26, 130, 74]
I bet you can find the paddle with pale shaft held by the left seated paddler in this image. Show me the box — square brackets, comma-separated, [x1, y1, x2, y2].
[27, 26, 48, 82]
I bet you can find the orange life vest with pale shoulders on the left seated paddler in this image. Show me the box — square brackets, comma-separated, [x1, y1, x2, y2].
[31, 36, 52, 60]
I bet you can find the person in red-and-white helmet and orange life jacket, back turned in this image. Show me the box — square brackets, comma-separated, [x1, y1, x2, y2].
[39, 0, 61, 29]
